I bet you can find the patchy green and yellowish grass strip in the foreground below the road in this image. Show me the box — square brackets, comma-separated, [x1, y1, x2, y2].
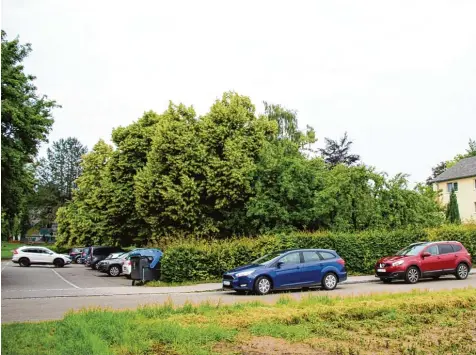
[2, 289, 476, 355]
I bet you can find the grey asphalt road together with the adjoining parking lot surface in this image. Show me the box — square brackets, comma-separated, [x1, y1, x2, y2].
[1, 262, 476, 323]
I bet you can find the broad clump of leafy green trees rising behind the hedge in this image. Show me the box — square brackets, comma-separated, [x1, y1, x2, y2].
[57, 92, 443, 246]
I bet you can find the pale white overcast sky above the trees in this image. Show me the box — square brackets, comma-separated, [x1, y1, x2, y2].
[2, 0, 476, 182]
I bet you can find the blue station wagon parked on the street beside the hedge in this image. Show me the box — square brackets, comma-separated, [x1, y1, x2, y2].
[223, 249, 347, 295]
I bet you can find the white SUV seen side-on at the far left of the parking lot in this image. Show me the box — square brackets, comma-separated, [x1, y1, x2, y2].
[12, 246, 71, 267]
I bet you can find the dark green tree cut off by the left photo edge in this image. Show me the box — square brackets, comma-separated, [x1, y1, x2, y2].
[1, 31, 58, 236]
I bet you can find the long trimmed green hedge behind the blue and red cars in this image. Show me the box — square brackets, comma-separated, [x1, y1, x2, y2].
[162, 225, 476, 282]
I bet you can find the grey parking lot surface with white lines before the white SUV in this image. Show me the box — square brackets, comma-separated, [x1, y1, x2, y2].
[2, 262, 131, 296]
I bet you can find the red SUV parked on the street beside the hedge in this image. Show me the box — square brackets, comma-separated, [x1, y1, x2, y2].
[375, 242, 472, 284]
